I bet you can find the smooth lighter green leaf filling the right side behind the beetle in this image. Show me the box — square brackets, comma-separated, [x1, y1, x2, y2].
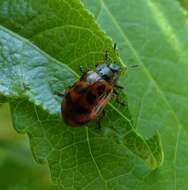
[83, 0, 188, 190]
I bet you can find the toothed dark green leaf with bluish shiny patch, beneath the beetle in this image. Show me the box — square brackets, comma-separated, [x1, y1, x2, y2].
[0, 0, 163, 189]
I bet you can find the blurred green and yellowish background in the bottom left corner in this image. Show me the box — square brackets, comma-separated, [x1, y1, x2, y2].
[0, 104, 57, 190]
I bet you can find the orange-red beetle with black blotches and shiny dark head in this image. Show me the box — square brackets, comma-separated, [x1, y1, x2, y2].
[61, 49, 122, 127]
